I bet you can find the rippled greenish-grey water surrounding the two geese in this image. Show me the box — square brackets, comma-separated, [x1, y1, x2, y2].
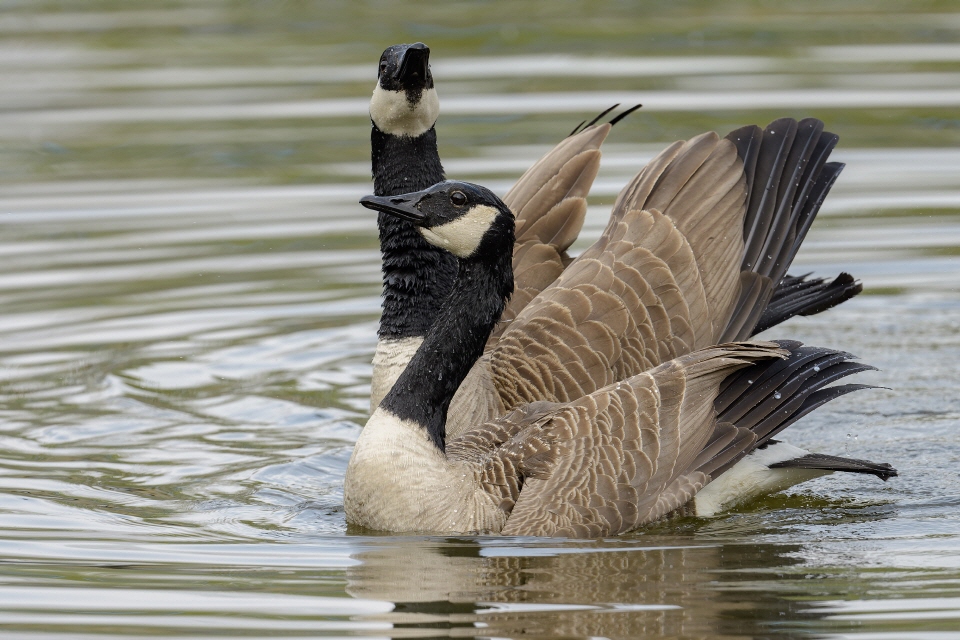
[0, 0, 960, 639]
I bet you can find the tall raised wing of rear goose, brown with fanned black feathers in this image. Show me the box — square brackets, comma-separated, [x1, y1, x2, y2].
[447, 118, 860, 437]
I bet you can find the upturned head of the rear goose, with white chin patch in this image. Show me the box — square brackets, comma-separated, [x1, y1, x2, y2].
[370, 42, 440, 137]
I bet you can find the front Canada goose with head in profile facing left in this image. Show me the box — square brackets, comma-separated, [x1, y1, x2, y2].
[344, 182, 896, 537]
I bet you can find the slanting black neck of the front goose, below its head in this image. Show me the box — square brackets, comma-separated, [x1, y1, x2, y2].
[380, 231, 513, 451]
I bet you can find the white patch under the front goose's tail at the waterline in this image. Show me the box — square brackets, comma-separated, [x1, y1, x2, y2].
[693, 442, 833, 517]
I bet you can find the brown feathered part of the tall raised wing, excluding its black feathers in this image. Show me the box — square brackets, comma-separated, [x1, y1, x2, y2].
[488, 134, 746, 408]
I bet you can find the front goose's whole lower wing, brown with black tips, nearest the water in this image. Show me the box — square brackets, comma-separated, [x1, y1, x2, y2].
[447, 341, 884, 537]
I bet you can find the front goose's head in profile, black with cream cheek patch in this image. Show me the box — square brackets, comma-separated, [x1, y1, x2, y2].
[360, 180, 514, 262]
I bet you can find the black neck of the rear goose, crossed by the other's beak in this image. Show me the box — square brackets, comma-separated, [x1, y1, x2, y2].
[370, 125, 457, 338]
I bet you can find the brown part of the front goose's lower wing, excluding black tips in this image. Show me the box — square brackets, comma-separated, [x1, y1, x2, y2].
[460, 343, 783, 537]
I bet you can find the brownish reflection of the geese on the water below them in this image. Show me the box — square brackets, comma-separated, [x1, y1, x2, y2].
[347, 536, 803, 638]
